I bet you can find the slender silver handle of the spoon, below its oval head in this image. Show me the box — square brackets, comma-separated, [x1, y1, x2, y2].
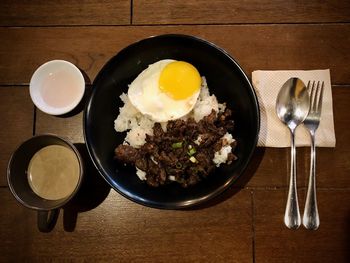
[284, 130, 301, 229]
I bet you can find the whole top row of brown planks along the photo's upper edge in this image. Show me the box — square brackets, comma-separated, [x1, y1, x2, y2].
[0, 0, 350, 26]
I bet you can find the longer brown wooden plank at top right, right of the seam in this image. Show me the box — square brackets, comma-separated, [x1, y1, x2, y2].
[133, 0, 350, 24]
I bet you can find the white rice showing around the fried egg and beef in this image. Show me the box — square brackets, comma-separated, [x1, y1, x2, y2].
[114, 77, 232, 167]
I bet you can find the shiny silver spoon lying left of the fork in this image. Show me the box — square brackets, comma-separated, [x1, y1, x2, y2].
[276, 78, 310, 229]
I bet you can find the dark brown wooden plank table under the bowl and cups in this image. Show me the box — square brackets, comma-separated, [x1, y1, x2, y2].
[0, 0, 350, 263]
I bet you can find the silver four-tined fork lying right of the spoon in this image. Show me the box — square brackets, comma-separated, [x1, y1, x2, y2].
[303, 81, 324, 230]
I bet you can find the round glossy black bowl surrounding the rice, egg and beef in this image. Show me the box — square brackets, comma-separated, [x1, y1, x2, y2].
[84, 35, 260, 209]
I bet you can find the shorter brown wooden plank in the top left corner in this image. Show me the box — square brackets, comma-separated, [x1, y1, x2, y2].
[0, 0, 131, 26]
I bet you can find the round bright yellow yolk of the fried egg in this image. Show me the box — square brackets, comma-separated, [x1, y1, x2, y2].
[159, 61, 201, 100]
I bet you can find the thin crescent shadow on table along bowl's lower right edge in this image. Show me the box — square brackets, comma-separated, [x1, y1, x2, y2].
[185, 147, 265, 210]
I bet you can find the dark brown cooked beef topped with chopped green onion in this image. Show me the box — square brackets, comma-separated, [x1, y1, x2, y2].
[115, 109, 237, 187]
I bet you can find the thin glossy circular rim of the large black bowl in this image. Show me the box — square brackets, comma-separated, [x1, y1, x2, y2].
[83, 34, 261, 210]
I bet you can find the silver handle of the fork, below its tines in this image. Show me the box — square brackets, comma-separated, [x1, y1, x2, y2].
[303, 131, 320, 230]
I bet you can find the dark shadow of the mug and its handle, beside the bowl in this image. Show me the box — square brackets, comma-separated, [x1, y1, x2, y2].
[63, 143, 111, 232]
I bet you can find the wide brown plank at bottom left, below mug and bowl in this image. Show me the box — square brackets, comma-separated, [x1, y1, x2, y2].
[0, 189, 252, 262]
